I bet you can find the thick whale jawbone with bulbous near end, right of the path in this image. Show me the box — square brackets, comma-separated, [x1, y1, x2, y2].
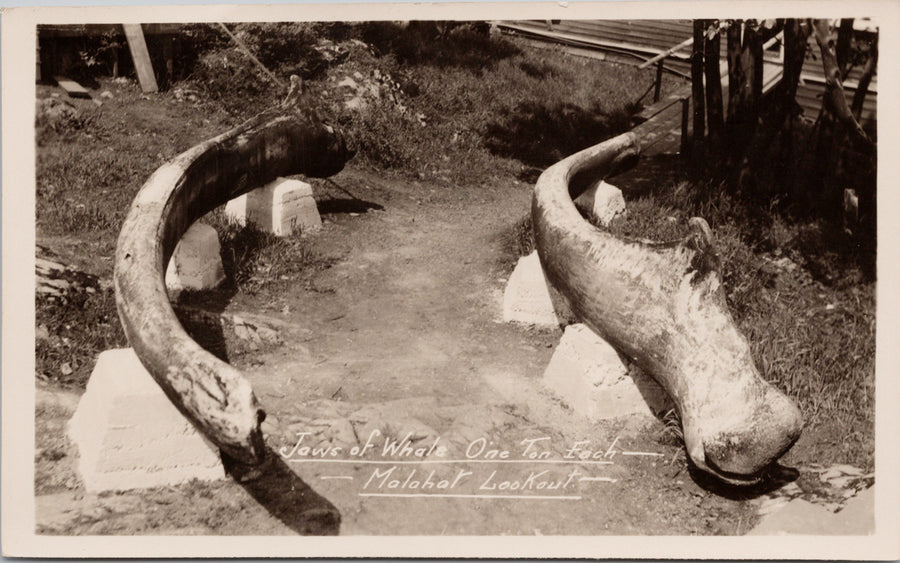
[532, 133, 802, 483]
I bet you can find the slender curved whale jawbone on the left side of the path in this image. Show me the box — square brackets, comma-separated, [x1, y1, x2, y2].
[114, 77, 352, 465]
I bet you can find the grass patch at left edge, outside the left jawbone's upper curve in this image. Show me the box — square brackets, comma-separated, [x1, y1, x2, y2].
[35, 81, 232, 248]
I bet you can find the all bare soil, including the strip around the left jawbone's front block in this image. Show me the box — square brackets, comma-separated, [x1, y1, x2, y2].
[35, 162, 840, 535]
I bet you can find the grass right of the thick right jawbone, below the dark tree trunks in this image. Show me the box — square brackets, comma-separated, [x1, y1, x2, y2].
[507, 178, 876, 470]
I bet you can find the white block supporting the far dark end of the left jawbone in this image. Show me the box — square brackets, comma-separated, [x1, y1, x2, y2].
[225, 178, 322, 237]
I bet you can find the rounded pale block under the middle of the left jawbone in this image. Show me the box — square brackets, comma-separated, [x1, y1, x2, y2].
[166, 223, 225, 295]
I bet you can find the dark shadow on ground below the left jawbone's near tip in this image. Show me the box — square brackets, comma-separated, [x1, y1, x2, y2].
[222, 449, 341, 536]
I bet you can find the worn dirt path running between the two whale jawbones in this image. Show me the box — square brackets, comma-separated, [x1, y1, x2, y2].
[206, 171, 750, 534]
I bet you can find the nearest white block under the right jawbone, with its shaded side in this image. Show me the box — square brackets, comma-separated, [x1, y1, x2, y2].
[544, 324, 673, 420]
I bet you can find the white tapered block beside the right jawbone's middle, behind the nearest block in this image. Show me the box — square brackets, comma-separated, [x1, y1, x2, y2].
[503, 252, 560, 328]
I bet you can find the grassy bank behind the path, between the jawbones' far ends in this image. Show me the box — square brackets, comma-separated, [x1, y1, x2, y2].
[352, 39, 672, 184]
